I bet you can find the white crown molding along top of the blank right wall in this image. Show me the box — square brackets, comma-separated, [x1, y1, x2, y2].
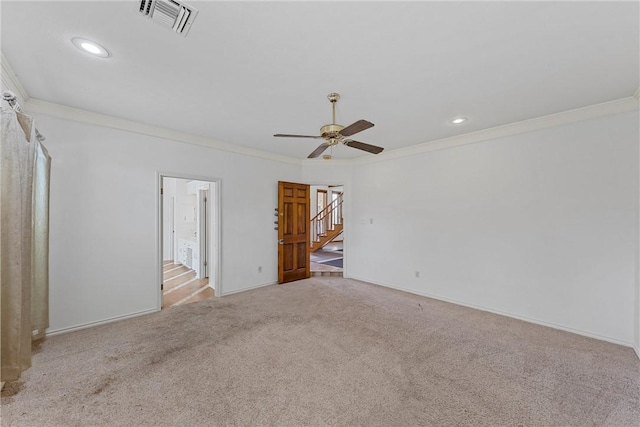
[352, 96, 638, 165]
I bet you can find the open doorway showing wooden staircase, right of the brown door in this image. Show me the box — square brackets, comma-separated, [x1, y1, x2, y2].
[309, 185, 344, 276]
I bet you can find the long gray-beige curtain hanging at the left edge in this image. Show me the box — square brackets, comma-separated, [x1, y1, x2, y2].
[0, 109, 49, 381]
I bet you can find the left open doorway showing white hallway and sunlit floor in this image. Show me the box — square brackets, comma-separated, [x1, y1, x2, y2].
[159, 175, 220, 309]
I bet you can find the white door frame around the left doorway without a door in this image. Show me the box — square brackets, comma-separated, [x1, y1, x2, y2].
[155, 171, 222, 311]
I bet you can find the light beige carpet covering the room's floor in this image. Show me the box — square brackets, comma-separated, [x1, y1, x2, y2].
[2, 278, 640, 426]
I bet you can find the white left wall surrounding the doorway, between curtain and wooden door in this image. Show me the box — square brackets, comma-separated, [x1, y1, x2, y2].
[36, 115, 301, 333]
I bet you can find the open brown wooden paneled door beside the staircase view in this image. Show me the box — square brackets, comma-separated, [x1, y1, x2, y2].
[278, 181, 311, 283]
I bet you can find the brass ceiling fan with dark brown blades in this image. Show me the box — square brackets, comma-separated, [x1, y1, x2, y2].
[273, 93, 384, 159]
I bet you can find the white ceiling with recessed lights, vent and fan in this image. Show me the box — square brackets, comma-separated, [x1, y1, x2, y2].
[1, 0, 640, 159]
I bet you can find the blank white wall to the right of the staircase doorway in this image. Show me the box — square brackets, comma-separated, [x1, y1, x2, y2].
[348, 112, 639, 345]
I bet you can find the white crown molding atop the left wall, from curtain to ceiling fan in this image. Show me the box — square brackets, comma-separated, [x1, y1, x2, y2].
[25, 98, 302, 166]
